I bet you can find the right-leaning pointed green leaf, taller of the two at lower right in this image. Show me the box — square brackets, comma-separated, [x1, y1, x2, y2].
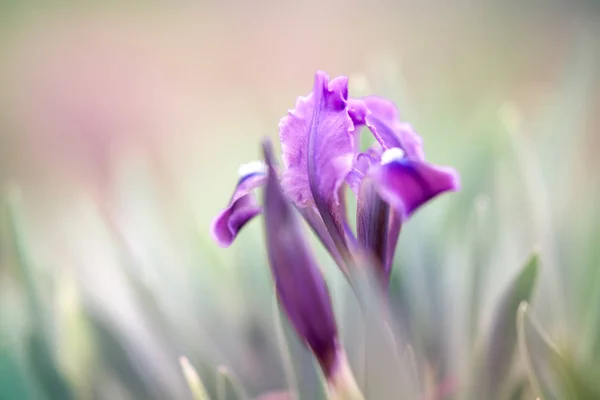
[472, 254, 539, 399]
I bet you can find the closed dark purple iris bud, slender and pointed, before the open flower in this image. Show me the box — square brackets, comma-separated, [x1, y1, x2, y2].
[263, 142, 339, 377]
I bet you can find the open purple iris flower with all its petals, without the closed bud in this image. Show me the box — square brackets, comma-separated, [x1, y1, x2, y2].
[212, 71, 459, 283]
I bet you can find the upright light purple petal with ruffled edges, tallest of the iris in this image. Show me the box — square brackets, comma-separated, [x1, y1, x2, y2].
[279, 71, 355, 207]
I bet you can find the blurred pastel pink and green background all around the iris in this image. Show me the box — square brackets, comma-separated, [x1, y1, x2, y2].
[0, 0, 600, 400]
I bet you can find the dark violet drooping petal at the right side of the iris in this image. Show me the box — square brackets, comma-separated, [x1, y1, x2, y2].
[369, 150, 460, 221]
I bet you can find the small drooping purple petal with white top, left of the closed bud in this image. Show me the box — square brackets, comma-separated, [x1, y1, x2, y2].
[211, 164, 267, 247]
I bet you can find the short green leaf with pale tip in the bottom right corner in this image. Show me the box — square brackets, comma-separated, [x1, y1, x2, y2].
[517, 302, 600, 400]
